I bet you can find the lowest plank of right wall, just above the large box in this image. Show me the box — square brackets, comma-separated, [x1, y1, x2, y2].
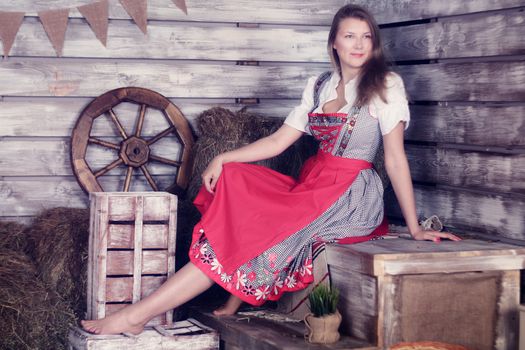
[385, 186, 525, 240]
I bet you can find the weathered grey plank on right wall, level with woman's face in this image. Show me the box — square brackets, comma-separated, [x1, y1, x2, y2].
[381, 9, 525, 61]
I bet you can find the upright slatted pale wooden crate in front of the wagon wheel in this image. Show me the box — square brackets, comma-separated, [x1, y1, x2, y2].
[87, 192, 177, 325]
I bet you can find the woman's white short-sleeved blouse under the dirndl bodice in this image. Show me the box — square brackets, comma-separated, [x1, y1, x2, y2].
[284, 72, 410, 135]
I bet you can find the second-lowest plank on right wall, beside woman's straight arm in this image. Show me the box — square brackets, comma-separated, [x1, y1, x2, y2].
[406, 145, 525, 194]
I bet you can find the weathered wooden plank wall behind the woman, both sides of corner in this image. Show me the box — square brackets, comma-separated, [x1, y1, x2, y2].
[0, 0, 525, 239]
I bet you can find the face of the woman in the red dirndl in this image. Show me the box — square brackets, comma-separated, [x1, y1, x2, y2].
[333, 17, 373, 75]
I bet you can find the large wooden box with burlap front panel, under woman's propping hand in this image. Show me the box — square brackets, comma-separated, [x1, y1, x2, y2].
[327, 238, 525, 350]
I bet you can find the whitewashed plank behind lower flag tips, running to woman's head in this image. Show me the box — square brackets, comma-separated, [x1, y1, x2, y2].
[10, 20, 329, 62]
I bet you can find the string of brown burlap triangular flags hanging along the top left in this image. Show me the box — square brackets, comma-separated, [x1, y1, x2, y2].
[0, 0, 188, 57]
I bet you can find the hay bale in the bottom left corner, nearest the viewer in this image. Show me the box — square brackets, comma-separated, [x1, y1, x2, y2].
[0, 248, 75, 349]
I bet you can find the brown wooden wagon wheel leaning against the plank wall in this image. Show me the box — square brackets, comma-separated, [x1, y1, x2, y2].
[71, 87, 194, 194]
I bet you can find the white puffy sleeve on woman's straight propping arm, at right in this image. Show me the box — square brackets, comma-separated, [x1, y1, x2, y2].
[370, 73, 410, 135]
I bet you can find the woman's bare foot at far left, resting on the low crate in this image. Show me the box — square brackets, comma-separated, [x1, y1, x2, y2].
[80, 307, 146, 335]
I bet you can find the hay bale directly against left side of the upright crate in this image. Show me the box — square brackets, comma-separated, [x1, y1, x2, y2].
[28, 208, 89, 318]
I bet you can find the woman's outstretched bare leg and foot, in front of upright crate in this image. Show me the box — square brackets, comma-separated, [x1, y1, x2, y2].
[80, 263, 213, 334]
